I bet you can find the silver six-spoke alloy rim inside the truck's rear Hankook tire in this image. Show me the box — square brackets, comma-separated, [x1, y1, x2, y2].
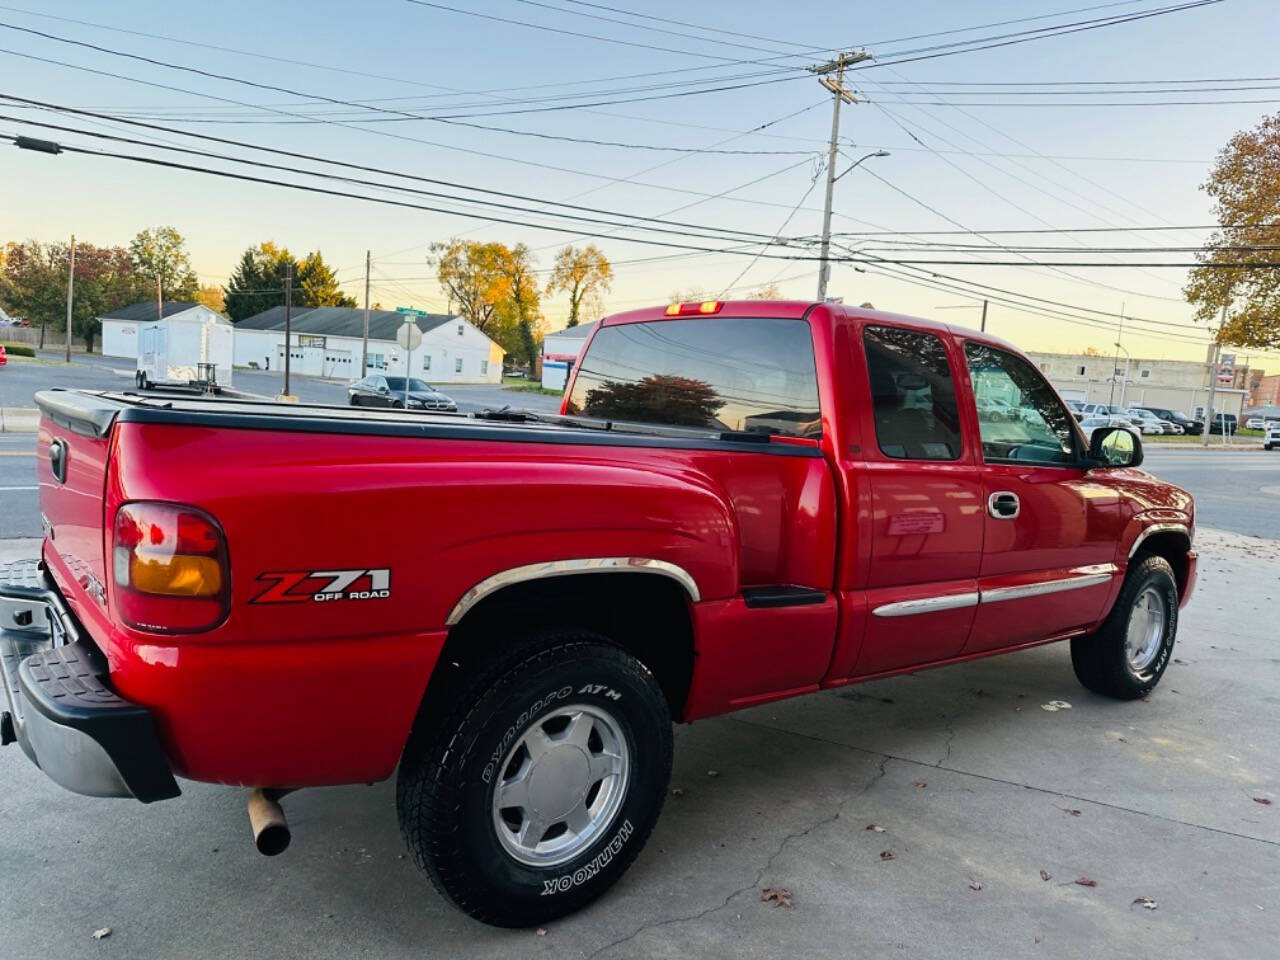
[493, 704, 631, 867]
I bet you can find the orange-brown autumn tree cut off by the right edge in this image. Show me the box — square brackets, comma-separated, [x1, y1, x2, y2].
[1183, 114, 1280, 349]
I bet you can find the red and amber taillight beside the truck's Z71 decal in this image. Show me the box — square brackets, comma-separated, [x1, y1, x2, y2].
[111, 500, 230, 634]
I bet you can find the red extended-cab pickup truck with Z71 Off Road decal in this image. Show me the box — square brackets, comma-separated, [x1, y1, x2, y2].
[0, 301, 1196, 925]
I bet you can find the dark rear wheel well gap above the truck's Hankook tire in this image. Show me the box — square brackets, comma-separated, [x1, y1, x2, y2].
[424, 573, 694, 719]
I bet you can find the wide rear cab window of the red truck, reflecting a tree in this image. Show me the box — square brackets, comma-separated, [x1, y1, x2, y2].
[566, 316, 822, 436]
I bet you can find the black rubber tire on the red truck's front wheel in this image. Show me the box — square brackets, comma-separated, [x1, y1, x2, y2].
[1071, 557, 1178, 700]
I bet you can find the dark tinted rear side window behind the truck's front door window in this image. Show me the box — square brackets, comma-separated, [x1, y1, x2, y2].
[863, 326, 961, 460]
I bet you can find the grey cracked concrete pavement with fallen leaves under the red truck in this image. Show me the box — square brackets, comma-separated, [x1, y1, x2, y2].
[0, 531, 1280, 960]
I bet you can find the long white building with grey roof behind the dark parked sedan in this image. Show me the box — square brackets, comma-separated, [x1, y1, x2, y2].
[236, 306, 503, 383]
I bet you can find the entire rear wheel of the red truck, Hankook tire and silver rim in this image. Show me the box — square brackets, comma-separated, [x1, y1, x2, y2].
[396, 634, 672, 927]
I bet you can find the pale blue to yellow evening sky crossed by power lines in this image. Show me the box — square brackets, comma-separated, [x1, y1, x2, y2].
[0, 0, 1280, 369]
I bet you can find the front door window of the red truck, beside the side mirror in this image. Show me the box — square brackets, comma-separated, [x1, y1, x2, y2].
[964, 342, 1075, 465]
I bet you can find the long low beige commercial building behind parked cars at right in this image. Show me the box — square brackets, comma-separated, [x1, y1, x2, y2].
[1028, 353, 1247, 416]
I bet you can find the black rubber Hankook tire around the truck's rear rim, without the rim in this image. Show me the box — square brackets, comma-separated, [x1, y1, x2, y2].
[396, 632, 672, 927]
